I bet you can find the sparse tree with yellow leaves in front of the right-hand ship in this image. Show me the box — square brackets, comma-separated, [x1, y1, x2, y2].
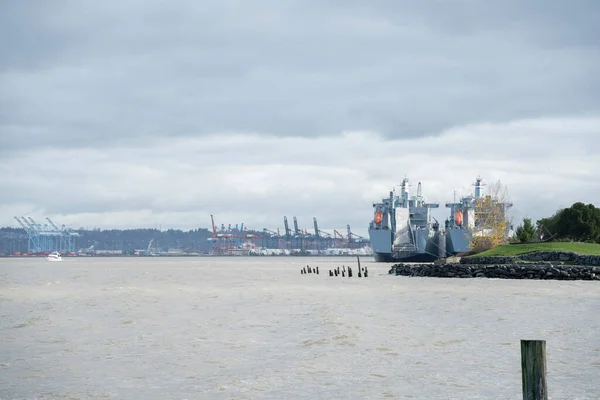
[470, 181, 512, 252]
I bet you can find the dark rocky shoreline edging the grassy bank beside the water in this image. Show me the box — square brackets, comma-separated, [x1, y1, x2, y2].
[389, 251, 600, 281]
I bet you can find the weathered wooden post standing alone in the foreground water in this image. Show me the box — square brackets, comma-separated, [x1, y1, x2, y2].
[521, 340, 548, 400]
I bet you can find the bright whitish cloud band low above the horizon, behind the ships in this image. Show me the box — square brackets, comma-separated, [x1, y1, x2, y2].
[0, 118, 600, 235]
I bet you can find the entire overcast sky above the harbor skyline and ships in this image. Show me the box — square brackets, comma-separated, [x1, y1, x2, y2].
[0, 0, 600, 236]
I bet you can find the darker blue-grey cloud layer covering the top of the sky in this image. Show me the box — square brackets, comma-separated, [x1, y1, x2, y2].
[0, 1, 600, 149]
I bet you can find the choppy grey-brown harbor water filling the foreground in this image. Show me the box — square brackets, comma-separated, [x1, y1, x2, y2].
[0, 257, 600, 400]
